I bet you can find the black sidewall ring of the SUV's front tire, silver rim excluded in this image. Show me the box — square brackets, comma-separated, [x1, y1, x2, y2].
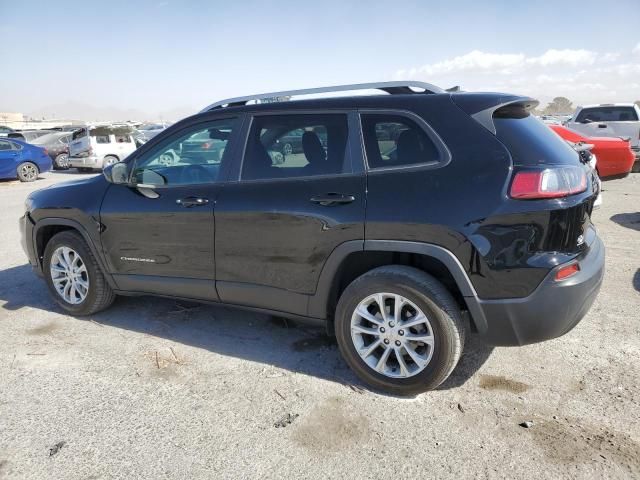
[43, 232, 99, 315]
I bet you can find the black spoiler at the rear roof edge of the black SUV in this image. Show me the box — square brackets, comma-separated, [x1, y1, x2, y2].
[451, 93, 540, 135]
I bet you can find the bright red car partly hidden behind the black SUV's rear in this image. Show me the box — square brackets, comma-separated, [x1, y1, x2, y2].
[549, 125, 635, 178]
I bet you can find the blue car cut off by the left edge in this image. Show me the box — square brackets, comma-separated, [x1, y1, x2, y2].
[0, 138, 52, 182]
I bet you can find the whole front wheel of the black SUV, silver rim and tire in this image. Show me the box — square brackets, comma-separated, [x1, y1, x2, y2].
[44, 231, 115, 315]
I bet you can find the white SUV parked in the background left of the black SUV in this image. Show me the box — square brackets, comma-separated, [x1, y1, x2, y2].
[69, 125, 136, 172]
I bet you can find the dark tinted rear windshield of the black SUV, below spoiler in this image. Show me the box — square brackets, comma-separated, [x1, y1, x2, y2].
[493, 114, 580, 166]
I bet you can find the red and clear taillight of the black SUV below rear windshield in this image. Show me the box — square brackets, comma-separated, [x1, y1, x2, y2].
[509, 167, 587, 200]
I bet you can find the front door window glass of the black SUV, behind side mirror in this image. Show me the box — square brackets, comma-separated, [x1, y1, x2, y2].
[133, 118, 237, 186]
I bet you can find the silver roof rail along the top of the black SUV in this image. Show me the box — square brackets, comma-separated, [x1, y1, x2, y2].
[200, 81, 446, 113]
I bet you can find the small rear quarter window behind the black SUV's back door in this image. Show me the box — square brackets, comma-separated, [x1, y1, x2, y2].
[361, 114, 441, 168]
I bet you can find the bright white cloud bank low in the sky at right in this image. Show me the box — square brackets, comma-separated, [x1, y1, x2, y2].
[393, 43, 640, 103]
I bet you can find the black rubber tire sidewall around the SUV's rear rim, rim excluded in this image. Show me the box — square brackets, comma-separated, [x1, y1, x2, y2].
[335, 275, 462, 395]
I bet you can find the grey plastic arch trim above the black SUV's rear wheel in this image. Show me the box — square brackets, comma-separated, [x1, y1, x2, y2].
[308, 240, 487, 334]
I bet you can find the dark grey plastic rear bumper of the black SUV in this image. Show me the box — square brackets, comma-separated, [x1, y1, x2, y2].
[478, 237, 605, 346]
